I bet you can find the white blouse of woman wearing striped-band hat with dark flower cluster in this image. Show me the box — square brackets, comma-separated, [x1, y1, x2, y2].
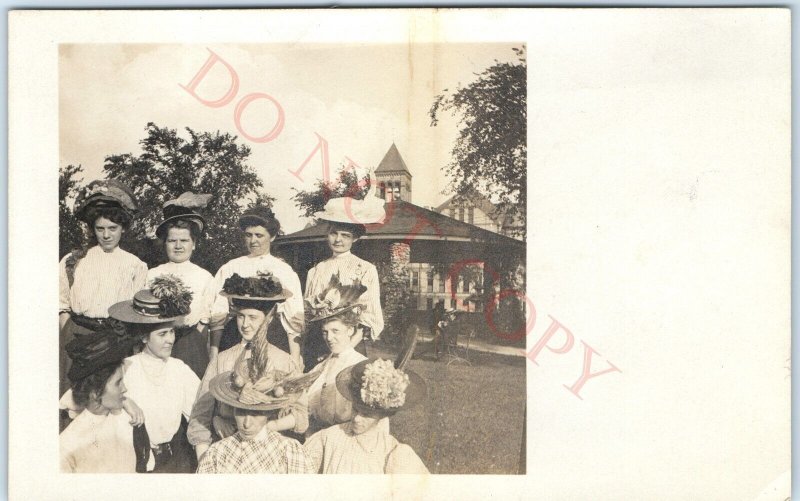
[123, 352, 200, 445]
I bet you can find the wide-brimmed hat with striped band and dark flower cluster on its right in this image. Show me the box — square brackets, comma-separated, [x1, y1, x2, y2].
[108, 274, 192, 324]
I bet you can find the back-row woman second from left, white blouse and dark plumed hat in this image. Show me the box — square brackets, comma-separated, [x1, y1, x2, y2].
[147, 192, 214, 378]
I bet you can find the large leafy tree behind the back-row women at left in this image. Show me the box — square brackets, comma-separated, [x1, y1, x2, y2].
[103, 122, 266, 273]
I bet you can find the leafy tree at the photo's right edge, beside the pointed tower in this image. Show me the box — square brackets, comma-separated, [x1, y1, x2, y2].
[429, 48, 527, 236]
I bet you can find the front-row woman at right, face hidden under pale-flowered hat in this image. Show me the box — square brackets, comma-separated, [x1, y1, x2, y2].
[304, 360, 428, 473]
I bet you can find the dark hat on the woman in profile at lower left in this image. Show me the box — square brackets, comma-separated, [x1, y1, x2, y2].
[65, 330, 137, 383]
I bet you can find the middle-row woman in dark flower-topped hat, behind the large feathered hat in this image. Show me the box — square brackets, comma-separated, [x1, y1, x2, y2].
[187, 273, 308, 459]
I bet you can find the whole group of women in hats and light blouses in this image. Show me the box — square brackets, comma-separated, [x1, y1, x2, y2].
[59, 180, 427, 473]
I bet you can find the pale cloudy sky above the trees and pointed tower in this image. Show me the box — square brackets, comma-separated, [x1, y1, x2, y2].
[59, 43, 521, 232]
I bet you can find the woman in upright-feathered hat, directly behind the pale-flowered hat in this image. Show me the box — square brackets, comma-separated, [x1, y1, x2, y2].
[305, 275, 367, 436]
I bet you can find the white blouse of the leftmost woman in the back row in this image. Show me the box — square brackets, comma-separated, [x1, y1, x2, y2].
[58, 245, 147, 318]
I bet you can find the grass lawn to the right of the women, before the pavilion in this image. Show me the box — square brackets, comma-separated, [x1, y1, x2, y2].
[370, 344, 526, 474]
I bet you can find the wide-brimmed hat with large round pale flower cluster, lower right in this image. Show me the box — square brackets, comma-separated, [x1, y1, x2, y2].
[336, 359, 427, 417]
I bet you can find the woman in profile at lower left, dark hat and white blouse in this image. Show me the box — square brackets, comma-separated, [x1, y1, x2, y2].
[58, 331, 148, 473]
